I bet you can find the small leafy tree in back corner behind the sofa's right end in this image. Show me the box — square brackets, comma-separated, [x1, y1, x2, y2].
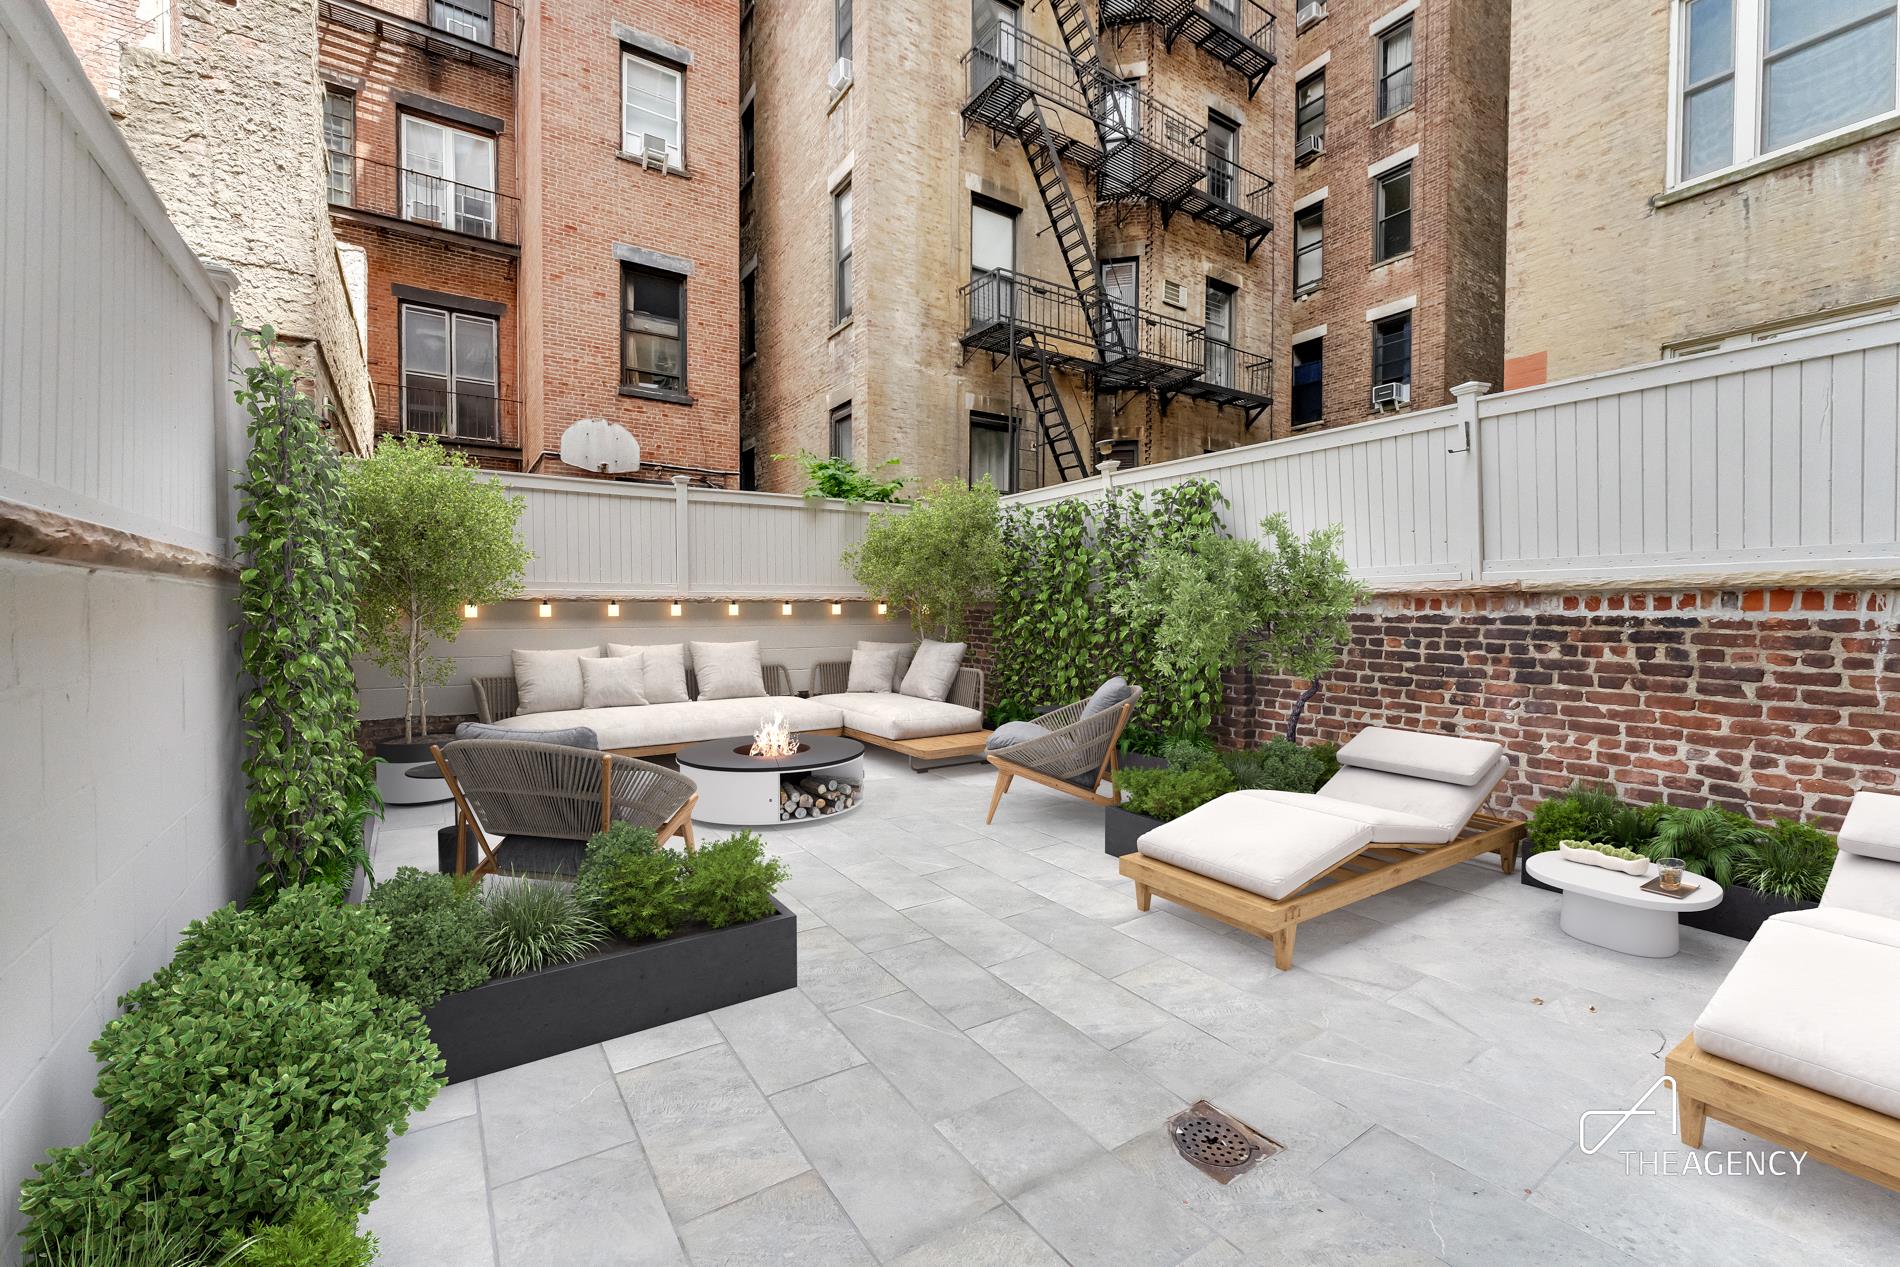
[844, 477, 999, 638]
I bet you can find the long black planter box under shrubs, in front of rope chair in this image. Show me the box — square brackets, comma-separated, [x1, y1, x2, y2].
[424, 898, 798, 1083]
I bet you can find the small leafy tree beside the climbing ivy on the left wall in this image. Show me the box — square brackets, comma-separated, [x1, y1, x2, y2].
[348, 437, 528, 743]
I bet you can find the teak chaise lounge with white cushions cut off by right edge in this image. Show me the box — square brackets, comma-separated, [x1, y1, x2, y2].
[1664, 792, 1900, 1191]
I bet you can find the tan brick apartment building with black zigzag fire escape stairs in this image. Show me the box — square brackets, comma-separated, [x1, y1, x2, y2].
[741, 0, 1292, 488]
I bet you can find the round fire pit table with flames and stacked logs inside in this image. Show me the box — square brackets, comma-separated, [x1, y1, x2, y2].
[675, 735, 865, 826]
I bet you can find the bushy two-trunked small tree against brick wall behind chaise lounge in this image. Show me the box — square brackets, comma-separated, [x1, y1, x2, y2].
[1117, 515, 1366, 741]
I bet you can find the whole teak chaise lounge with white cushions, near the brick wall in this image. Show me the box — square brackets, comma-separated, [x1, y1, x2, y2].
[1121, 728, 1524, 969]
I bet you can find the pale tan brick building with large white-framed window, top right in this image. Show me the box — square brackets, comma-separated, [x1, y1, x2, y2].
[1505, 0, 1900, 386]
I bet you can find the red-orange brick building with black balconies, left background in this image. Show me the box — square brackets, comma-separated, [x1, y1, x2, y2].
[317, 0, 739, 486]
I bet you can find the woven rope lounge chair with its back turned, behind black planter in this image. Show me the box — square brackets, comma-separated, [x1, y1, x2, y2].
[431, 739, 699, 876]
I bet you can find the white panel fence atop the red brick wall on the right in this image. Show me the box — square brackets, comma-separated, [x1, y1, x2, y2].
[1005, 317, 1900, 589]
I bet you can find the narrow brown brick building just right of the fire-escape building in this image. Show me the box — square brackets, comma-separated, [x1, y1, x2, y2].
[1286, 0, 1511, 429]
